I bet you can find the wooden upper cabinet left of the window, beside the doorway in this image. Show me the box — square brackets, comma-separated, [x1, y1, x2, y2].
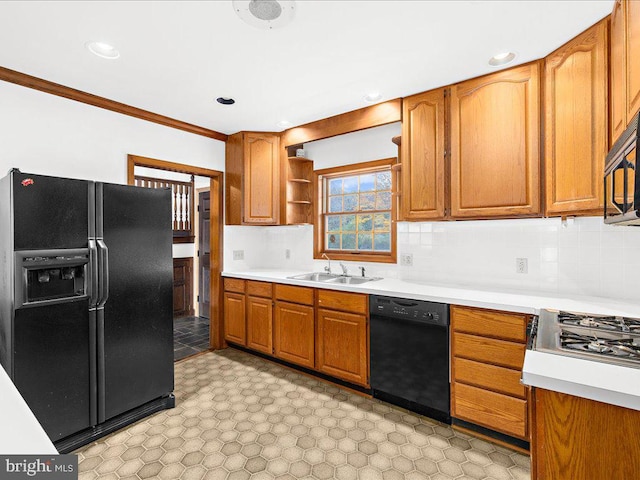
[225, 132, 280, 225]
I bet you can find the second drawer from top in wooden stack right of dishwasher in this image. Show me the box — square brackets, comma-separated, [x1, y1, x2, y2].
[452, 332, 525, 370]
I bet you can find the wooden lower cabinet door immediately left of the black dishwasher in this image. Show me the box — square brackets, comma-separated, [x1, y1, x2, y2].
[316, 308, 369, 386]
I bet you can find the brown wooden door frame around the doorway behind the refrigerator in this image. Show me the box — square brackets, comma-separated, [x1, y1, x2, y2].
[127, 155, 224, 350]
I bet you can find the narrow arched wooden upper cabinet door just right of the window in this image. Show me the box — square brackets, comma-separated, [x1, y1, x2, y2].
[401, 88, 445, 220]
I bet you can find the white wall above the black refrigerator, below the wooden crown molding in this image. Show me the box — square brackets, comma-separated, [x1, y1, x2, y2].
[0, 81, 225, 257]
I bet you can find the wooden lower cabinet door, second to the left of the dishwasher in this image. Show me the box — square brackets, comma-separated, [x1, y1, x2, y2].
[273, 300, 315, 368]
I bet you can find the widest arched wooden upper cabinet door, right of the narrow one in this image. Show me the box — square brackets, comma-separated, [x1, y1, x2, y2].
[450, 62, 541, 218]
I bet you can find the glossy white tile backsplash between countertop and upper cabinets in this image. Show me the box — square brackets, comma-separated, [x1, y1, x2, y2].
[224, 217, 640, 299]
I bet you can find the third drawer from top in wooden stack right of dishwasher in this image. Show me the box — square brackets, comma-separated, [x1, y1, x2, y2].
[453, 357, 527, 398]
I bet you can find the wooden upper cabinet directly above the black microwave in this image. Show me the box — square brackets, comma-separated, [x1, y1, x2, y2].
[609, 0, 640, 145]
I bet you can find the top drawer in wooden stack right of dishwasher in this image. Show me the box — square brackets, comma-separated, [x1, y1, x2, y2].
[451, 306, 528, 343]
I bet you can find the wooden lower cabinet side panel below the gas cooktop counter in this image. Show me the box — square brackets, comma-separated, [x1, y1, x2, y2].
[531, 389, 640, 480]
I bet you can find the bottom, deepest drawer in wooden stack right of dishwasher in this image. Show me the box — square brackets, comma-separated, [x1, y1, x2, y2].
[451, 383, 528, 439]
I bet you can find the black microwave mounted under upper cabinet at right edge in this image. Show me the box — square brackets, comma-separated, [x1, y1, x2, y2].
[604, 112, 640, 226]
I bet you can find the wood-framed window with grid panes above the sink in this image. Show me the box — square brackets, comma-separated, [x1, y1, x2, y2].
[314, 158, 396, 262]
